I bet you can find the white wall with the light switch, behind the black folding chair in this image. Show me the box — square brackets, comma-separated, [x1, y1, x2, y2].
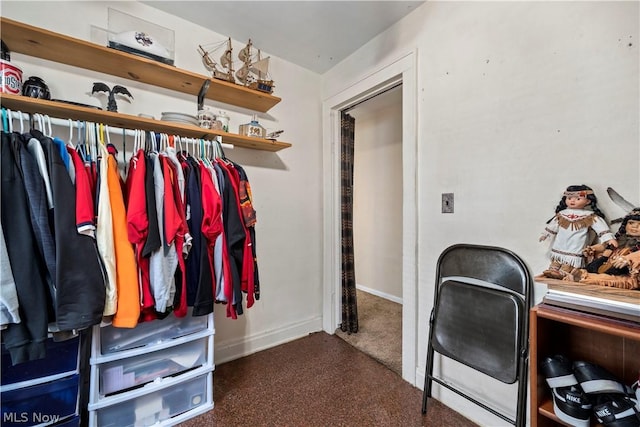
[322, 2, 640, 425]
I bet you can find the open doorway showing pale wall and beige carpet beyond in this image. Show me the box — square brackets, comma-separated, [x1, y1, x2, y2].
[336, 83, 402, 375]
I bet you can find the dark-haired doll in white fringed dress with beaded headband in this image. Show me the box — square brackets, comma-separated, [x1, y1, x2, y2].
[540, 185, 618, 280]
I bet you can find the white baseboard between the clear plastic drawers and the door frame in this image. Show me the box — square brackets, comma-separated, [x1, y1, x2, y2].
[214, 317, 322, 364]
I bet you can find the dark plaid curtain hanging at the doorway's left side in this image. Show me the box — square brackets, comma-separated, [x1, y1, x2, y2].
[340, 113, 358, 333]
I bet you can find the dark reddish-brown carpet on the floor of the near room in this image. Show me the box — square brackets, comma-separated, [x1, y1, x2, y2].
[181, 332, 475, 427]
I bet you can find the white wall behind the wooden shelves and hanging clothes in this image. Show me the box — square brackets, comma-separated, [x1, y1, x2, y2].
[1, 0, 322, 363]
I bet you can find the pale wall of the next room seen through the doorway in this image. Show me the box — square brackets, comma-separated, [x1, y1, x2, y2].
[349, 88, 402, 302]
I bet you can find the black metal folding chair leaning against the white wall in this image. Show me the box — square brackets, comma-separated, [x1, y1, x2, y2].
[422, 244, 533, 427]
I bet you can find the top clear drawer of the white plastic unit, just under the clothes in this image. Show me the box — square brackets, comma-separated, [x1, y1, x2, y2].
[99, 310, 210, 354]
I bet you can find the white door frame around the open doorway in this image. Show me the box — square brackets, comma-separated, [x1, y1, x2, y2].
[322, 51, 419, 386]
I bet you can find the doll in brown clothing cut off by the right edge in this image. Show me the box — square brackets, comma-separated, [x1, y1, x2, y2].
[575, 208, 640, 289]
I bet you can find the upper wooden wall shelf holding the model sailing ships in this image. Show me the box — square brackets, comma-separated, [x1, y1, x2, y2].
[0, 17, 281, 113]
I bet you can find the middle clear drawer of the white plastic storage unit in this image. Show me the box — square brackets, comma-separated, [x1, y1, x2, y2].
[98, 338, 208, 396]
